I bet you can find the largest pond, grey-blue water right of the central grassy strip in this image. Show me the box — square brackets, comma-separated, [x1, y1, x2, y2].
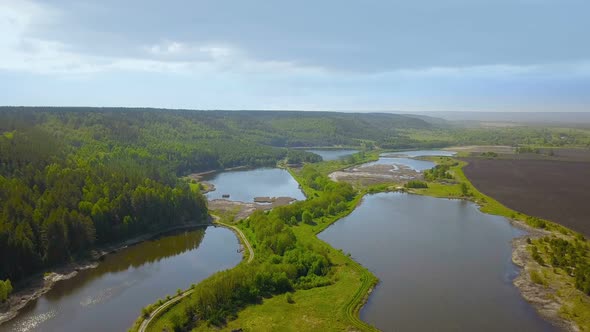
[319, 193, 554, 331]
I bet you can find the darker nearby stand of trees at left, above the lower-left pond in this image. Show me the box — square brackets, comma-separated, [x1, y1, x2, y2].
[0, 130, 207, 281]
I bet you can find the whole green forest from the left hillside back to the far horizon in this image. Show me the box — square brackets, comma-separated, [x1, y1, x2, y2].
[0, 107, 590, 288]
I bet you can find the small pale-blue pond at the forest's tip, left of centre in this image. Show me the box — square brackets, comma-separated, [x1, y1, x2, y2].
[204, 168, 305, 202]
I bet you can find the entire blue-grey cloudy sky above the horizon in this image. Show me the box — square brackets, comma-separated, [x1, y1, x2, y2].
[0, 0, 590, 112]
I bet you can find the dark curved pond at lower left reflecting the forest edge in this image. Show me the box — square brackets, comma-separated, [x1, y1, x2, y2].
[0, 226, 242, 331]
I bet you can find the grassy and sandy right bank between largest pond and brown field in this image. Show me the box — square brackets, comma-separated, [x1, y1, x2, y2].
[409, 157, 590, 331]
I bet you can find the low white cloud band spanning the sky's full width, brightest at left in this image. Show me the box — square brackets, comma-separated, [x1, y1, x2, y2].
[0, 0, 590, 82]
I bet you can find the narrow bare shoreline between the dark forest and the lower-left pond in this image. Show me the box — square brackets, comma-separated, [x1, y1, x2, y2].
[0, 223, 215, 325]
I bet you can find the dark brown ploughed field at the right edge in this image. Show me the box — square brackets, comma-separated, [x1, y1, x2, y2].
[464, 158, 590, 236]
